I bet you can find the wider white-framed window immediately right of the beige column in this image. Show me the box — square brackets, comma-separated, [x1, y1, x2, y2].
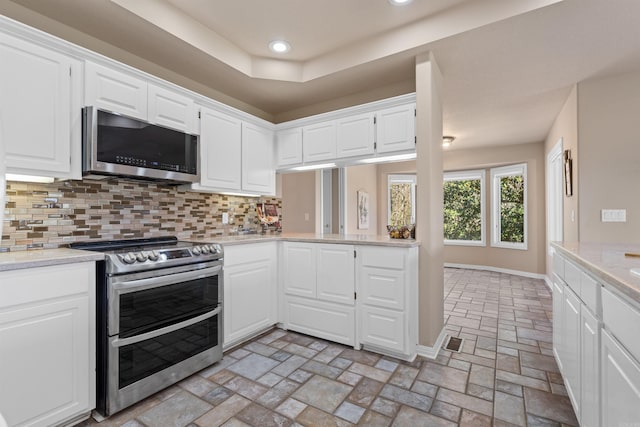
[443, 170, 485, 246]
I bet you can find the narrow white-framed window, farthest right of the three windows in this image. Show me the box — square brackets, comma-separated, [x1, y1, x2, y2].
[491, 164, 527, 250]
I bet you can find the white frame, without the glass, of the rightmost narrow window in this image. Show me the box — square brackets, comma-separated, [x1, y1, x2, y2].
[491, 163, 529, 251]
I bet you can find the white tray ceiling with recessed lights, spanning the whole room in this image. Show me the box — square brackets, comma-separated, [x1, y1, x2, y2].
[0, 0, 640, 149]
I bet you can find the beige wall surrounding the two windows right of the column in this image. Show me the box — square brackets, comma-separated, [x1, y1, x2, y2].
[444, 142, 546, 274]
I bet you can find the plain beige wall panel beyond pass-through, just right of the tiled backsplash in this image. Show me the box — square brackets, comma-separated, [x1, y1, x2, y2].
[282, 171, 316, 233]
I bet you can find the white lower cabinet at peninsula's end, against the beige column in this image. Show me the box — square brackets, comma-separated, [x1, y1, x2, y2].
[356, 246, 418, 359]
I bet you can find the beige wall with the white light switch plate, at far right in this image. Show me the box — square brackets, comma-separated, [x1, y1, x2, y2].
[576, 73, 640, 243]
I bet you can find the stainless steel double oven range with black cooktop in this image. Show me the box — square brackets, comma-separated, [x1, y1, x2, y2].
[70, 237, 224, 417]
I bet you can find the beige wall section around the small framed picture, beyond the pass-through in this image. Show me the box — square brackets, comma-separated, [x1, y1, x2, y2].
[345, 165, 378, 234]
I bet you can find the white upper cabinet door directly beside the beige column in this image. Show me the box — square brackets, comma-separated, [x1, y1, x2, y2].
[376, 104, 416, 153]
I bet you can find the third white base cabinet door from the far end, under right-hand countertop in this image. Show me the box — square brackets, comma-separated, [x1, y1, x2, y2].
[580, 304, 600, 427]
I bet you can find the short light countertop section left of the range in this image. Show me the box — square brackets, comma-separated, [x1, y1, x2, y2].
[0, 248, 104, 271]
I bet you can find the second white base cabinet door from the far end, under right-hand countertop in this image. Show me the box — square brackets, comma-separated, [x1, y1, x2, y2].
[561, 285, 581, 419]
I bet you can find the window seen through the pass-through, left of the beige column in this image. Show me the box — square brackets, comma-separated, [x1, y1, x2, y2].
[387, 175, 416, 226]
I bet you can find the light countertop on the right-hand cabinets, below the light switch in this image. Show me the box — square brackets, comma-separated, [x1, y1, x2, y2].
[552, 242, 640, 303]
